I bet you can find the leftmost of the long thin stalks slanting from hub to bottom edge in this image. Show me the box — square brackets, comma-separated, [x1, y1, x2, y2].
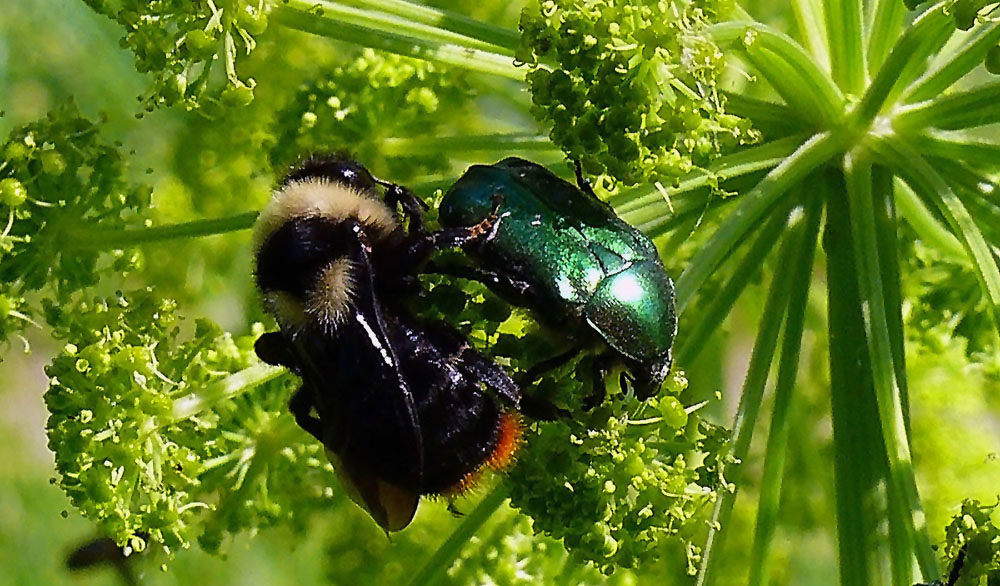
[695, 204, 806, 586]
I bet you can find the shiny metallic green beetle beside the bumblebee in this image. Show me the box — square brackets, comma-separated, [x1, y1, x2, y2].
[439, 157, 677, 400]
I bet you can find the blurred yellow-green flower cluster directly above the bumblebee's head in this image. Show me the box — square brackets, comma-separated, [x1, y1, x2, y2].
[271, 49, 472, 181]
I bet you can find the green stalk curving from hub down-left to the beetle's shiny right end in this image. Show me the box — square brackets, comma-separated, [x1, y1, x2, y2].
[676, 133, 842, 313]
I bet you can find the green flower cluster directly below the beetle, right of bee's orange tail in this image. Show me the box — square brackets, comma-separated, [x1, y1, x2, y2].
[510, 376, 726, 574]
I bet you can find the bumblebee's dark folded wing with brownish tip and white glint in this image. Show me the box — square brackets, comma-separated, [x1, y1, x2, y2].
[286, 222, 424, 531]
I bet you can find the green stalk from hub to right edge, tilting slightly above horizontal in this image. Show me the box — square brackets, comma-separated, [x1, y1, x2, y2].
[893, 82, 1000, 133]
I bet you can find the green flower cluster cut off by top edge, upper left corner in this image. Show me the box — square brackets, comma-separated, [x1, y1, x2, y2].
[84, 0, 268, 111]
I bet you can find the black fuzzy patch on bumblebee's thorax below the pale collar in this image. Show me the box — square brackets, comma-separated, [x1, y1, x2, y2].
[257, 218, 351, 299]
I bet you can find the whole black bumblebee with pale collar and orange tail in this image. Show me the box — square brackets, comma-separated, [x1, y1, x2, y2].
[255, 155, 521, 532]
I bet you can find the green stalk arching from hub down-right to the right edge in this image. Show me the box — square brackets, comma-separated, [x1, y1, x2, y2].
[871, 137, 1000, 324]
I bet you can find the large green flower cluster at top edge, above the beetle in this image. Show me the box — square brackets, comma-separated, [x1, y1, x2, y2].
[517, 0, 756, 185]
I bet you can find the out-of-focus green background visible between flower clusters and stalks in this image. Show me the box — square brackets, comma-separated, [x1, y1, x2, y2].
[0, 0, 1000, 586]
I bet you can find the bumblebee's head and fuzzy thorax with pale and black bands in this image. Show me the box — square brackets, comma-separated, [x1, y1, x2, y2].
[254, 156, 398, 329]
